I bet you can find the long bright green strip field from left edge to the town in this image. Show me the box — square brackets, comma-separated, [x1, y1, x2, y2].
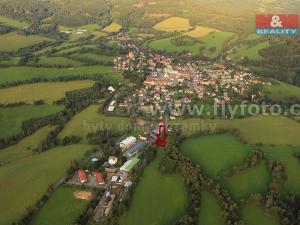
[0, 66, 123, 84]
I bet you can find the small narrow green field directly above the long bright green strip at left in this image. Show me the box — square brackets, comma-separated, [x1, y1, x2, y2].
[30, 56, 83, 67]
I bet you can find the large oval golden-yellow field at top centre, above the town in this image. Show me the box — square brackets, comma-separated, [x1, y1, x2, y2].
[153, 17, 191, 32]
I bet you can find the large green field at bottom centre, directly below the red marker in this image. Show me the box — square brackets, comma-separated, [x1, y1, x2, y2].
[120, 151, 187, 225]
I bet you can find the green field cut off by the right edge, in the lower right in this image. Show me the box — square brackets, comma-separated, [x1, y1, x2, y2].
[265, 146, 300, 195]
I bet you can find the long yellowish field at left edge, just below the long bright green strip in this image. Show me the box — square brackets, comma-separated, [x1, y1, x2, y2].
[0, 80, 94, 104]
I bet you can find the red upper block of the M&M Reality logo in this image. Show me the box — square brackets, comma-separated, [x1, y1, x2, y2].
[256, 14, 299, 29]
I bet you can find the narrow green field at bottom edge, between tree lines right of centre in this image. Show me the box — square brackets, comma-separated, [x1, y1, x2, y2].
[198, 191, 225, 225]
